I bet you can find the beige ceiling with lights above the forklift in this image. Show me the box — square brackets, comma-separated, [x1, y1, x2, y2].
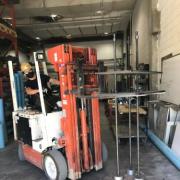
[9, 0, 135, 40]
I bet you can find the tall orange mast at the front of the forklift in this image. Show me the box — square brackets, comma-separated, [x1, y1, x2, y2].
[47, 45, 102, 179]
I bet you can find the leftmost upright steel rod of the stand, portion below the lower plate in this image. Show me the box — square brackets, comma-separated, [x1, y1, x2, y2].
[115, 98, 120, 176]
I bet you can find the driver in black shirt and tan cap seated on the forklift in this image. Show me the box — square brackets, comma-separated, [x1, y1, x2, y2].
[21, 63, 60, 112]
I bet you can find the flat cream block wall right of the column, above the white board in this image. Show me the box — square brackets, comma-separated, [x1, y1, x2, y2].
[158, 0, 180, 58]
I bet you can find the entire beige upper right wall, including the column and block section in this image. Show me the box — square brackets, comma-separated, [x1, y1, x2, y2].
[131, 0, 180, 89]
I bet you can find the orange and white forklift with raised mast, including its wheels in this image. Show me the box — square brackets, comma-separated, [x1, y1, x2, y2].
[8, 44, 107, 180]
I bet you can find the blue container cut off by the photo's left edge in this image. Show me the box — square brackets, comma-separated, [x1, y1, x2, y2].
[0, 99, 5, 149]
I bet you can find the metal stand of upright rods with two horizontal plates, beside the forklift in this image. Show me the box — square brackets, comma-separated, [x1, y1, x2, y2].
[91, 32, 165, 180]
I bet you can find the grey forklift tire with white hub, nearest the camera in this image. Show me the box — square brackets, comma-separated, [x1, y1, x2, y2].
[43, 150, 68, 180]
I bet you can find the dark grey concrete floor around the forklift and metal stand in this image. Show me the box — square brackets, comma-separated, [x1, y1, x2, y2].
[0, 105, 180, 180]
